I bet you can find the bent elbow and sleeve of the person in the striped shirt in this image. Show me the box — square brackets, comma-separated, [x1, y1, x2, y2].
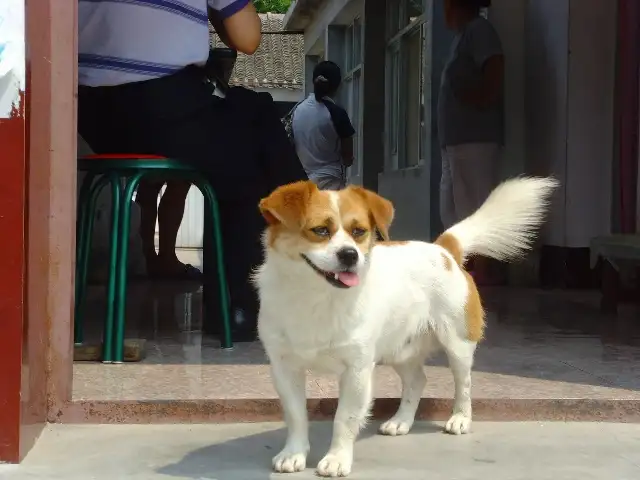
[208, 0, 262, 55]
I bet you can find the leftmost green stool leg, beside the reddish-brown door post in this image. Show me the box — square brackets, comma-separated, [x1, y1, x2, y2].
[73, 173, 95, 344]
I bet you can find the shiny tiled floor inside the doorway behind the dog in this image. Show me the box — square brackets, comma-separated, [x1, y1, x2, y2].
[74, 284, 640, 401]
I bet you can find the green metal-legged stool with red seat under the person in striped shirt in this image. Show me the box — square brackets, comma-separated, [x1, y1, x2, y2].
[74, 154, 233, 363]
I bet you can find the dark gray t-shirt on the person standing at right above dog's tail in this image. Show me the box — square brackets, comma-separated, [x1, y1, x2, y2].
[438, 17, 504, 147]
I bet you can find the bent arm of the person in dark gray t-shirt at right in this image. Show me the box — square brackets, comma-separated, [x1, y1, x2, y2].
[457, 21, 504, 109]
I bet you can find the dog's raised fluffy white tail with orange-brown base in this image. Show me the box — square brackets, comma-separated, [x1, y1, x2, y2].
[435, 177, 559, 266]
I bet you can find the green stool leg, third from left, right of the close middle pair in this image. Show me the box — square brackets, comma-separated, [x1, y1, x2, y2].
[113, 171, 146, 363]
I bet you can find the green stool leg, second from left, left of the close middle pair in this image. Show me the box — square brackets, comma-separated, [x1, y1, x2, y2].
[102, 172, 122, 363]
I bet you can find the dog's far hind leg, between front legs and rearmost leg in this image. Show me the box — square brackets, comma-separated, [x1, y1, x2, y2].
[379, 358, 427, 435]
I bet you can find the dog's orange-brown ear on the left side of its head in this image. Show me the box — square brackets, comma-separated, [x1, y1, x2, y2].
[255, 181, 318, 228]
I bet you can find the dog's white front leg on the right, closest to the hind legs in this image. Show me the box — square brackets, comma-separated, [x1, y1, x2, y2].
[317, 362, 374, 477]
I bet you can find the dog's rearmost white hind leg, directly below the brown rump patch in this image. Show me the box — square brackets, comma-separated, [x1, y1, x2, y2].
[437, 331, 476, 435]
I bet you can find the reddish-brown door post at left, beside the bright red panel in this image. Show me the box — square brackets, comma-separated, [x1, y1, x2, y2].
[25, 0, 78, 432]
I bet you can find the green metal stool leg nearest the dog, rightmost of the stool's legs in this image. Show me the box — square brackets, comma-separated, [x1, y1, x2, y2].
[197, 180, 233, 349]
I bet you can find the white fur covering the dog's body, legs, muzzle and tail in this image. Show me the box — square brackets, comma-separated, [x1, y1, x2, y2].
[256, 178, 556, 477]
